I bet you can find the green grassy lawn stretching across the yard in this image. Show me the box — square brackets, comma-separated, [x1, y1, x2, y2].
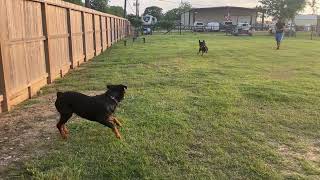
[10, 34, 320, 179]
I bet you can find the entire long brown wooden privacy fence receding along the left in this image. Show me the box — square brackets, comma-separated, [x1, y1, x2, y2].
[0, 0, 131, 112]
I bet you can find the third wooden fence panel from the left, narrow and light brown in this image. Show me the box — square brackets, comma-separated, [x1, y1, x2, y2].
[70, 10, 85, 67]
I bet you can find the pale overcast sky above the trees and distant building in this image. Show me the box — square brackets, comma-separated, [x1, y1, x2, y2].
[110, 0, 310, 14]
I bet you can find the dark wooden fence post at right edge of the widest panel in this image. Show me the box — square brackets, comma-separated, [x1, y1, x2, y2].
[41, 2, 53, 84]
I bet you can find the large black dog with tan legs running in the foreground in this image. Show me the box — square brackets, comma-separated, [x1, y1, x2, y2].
[55, 84, 127, 139]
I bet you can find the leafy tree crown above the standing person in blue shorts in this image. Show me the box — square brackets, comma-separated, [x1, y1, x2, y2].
[259, 0, 306, 20]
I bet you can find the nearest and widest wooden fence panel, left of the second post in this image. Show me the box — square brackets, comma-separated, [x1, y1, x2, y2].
[2, 0, 48, 105]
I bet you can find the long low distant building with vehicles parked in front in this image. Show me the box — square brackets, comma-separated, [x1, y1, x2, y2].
[181, 6, 258, 26]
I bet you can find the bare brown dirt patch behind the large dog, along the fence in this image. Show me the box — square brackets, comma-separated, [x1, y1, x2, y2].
[0, 94, 58, 177]
